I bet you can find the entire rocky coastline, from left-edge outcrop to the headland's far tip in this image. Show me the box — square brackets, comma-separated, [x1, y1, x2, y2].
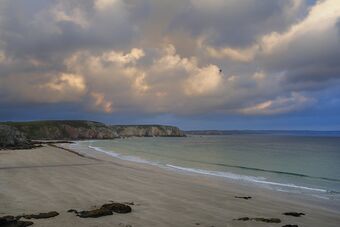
[0, 120, 185, 149]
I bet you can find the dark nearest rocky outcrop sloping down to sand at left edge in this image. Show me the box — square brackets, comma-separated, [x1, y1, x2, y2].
[0, 125, 33, 150]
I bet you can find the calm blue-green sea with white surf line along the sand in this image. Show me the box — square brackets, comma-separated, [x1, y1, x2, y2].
[76, 134, 340, 200]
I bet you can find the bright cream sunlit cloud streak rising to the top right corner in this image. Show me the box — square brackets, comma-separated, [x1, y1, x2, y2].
[205, 0, 340, 62]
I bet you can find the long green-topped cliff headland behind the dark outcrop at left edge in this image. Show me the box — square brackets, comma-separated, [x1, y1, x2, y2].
[2, 120, 184, 140]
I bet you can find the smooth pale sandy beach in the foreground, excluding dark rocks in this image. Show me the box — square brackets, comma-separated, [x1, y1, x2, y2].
[0, 145, 340, 227]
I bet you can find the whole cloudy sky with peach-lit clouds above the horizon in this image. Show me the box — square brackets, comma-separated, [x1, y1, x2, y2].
[0, 0, 340, 130]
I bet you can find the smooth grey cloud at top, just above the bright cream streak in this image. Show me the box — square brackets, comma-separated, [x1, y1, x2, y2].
[171, 0, 305, 47]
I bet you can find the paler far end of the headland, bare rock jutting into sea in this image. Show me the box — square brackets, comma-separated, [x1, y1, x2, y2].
[111, 125, 185, 137]
